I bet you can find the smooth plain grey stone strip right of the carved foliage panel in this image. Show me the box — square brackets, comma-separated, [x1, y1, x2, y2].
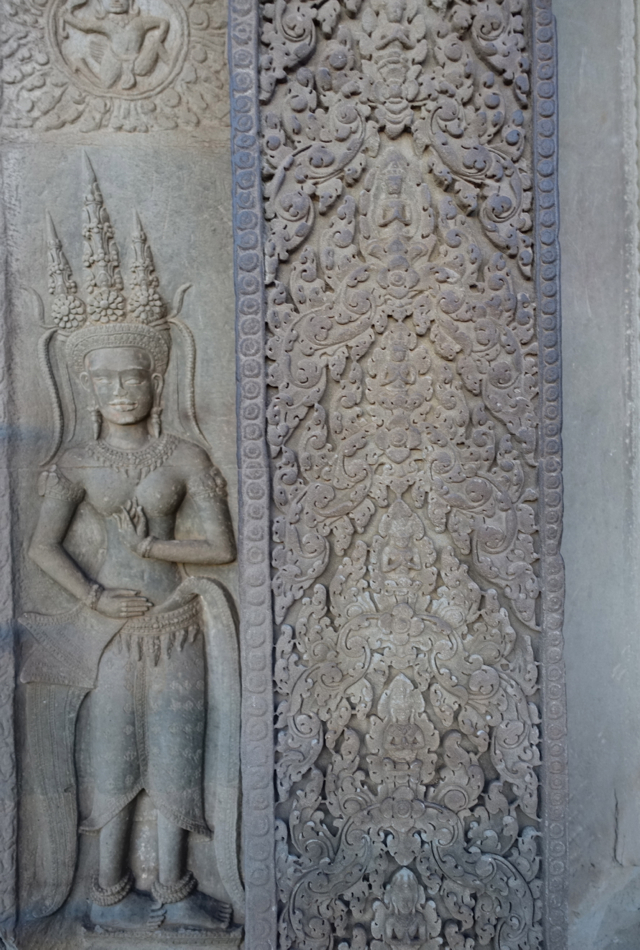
[554, 0, 640, 950]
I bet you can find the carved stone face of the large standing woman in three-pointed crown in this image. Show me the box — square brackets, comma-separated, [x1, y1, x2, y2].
[81, 346, 162, 426]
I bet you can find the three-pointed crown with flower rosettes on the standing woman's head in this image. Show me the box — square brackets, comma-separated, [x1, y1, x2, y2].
[47, 156, 171, 375]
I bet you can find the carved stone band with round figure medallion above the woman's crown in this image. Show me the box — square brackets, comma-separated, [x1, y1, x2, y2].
[2, 0, 228, 132]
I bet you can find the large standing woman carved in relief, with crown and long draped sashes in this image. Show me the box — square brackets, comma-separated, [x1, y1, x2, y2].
[20, 158, 244, 946]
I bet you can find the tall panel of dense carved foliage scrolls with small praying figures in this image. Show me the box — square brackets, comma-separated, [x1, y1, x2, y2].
[261, 0, 564, 950]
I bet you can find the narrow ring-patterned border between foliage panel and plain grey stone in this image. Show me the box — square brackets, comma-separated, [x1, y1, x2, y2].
[532, 0, 568, 950]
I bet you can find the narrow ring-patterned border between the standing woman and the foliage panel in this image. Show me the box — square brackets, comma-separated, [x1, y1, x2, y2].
[229, 0, 277, 950]
